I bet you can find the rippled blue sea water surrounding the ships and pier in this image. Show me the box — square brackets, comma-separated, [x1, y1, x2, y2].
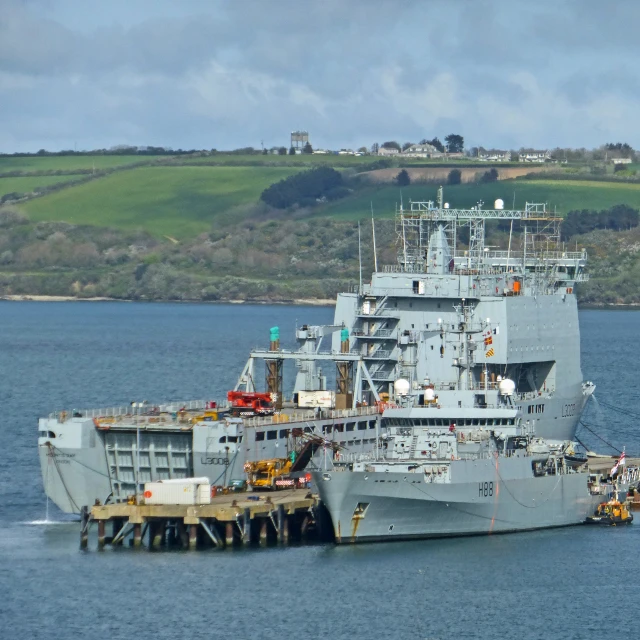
[0, 302, 640, 640]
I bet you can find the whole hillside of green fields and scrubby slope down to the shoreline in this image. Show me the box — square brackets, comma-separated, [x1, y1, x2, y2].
[0, 154, 640, 304]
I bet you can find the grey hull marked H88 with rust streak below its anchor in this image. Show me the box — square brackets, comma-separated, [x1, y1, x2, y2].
[314, 462, 602, 544]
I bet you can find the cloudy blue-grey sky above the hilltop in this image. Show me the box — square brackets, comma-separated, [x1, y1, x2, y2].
[0, 0, 640, 153]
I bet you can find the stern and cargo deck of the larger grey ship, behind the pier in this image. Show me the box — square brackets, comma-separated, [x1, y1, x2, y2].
[38, 324, 381, 513]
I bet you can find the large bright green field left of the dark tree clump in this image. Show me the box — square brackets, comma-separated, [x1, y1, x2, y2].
[21, 167, 299, 238]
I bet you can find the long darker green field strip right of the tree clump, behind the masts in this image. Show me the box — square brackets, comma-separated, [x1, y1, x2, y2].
[317, 180, 640, 219]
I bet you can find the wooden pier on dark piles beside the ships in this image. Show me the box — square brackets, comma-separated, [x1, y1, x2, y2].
[80, 489, 331, 550]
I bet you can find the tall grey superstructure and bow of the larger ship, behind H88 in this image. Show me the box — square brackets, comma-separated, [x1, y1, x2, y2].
[335, 192, 593, 441]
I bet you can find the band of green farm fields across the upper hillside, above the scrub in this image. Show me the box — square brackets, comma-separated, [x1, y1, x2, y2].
[7, 154, 640, 239]
